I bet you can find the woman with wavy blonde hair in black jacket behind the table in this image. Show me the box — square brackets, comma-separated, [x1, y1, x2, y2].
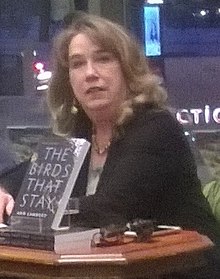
[0, 15, 217, 245]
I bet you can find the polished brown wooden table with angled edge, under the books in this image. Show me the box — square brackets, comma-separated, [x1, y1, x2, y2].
[0, 231, 213, 279]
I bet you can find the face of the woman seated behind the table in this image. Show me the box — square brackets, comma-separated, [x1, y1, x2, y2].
[69, 33, 126, 116]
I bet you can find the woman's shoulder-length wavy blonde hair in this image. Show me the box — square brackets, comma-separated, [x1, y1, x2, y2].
[48, 14, 167, 138]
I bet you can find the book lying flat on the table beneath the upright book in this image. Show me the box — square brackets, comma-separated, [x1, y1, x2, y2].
[0, 227, 100, 254]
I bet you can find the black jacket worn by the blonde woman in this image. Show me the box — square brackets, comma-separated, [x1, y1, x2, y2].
[0, 107, 220, 245]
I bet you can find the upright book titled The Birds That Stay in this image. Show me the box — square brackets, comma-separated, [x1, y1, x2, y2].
[9, 137, 90, 232]
